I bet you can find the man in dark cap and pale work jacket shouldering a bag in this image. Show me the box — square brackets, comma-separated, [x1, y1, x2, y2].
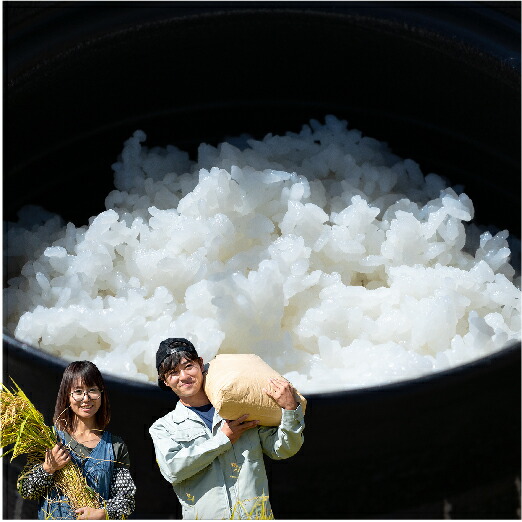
[149, 338, 304, 519]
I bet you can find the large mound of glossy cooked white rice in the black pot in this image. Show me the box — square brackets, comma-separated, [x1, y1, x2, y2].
[4, 116, 520, 394]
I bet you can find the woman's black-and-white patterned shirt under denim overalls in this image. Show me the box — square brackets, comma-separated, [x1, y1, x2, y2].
[18, 432, 136, 519]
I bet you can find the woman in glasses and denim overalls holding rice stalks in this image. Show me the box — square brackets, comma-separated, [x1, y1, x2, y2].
[18, 361, 136, 520]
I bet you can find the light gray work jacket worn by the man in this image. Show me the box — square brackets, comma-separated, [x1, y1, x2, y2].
[149, 401, 304, 519]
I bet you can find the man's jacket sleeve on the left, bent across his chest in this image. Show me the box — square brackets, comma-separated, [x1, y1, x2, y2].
[149, 420, 232, 484]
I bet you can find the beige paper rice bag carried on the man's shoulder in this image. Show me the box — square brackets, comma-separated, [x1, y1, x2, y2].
[205, 353, 306, 426]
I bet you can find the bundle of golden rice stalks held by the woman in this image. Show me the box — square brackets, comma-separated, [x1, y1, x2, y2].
[0, 379, 103, 510]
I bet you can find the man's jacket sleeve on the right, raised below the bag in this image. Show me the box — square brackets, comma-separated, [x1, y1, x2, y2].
[259, 404, 305, 460]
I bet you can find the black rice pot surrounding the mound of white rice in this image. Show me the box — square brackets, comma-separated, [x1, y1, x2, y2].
[3, 2, 520, 519]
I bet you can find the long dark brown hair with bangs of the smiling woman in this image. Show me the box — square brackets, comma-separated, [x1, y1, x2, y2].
[53, 361, 111, 433]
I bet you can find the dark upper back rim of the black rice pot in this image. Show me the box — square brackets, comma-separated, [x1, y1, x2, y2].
[6, 0, 521, 89]
